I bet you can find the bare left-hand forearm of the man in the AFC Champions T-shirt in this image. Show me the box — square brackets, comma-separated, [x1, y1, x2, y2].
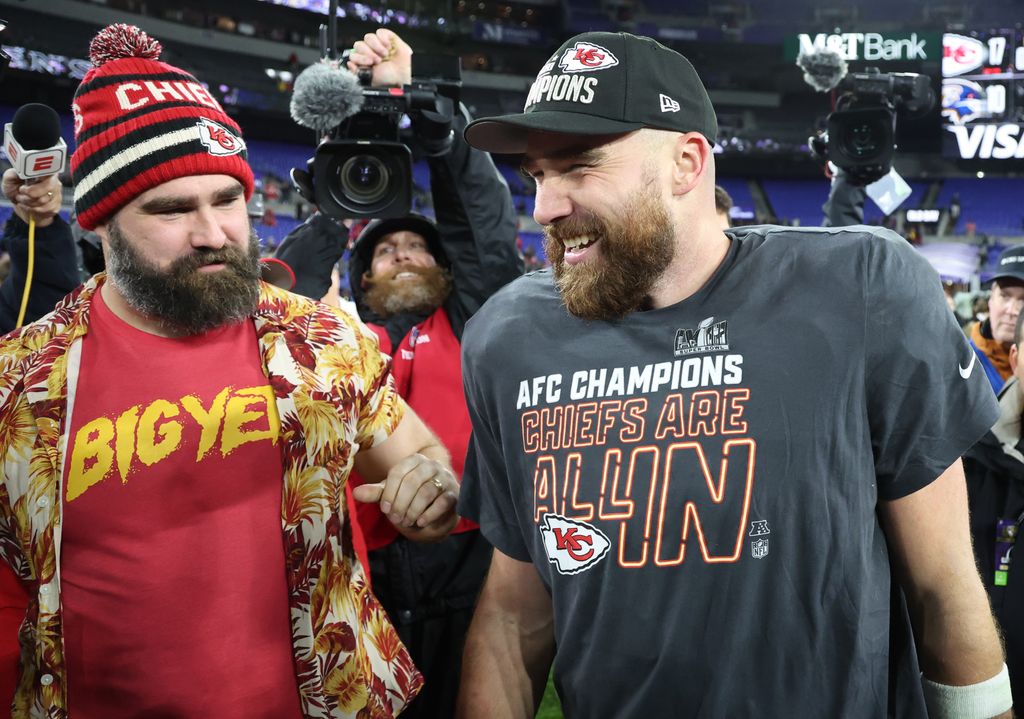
[456, 549, 555, 719]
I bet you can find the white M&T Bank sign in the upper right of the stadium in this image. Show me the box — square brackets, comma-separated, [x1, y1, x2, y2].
[785, 33, 942, 62]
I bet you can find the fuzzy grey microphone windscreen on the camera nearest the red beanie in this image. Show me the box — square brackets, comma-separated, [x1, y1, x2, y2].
[290, 62, 362, 133]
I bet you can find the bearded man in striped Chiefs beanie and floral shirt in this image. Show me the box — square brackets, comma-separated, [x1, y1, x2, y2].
[0, 25, 459, 719]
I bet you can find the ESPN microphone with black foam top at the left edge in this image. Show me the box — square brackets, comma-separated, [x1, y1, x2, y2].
[3, 102, 68, 179]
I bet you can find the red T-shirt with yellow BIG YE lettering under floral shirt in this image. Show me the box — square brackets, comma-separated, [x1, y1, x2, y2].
[60, 292, 301, 719]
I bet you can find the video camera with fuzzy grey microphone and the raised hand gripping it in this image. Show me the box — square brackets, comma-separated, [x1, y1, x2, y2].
[291, 28, 462, 219]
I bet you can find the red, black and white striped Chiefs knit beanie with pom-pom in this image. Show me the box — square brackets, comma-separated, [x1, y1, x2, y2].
[71, 24, 253, 229]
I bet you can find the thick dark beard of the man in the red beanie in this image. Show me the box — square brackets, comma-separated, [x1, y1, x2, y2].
[106, 220, 260, 335]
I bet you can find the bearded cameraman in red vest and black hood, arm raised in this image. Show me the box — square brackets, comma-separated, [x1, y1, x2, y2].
[276, 29, 523, 717]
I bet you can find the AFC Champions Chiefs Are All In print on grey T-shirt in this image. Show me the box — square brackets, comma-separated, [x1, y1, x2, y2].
[516, 348, 749, 574]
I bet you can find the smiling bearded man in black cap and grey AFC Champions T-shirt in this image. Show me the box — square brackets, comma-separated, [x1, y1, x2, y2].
[458, 33, 1012, 719]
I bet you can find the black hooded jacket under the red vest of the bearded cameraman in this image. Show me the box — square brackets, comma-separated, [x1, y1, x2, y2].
[276, 104, 523, 346]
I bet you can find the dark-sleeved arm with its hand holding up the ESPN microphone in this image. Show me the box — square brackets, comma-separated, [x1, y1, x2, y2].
[0, 103, 81, 335]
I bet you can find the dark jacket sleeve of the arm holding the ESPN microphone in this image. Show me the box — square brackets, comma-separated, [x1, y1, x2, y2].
[0, 215, 82, 335]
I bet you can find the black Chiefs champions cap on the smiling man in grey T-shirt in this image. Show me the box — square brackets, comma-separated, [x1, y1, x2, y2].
[466, 33, 718, 155]
